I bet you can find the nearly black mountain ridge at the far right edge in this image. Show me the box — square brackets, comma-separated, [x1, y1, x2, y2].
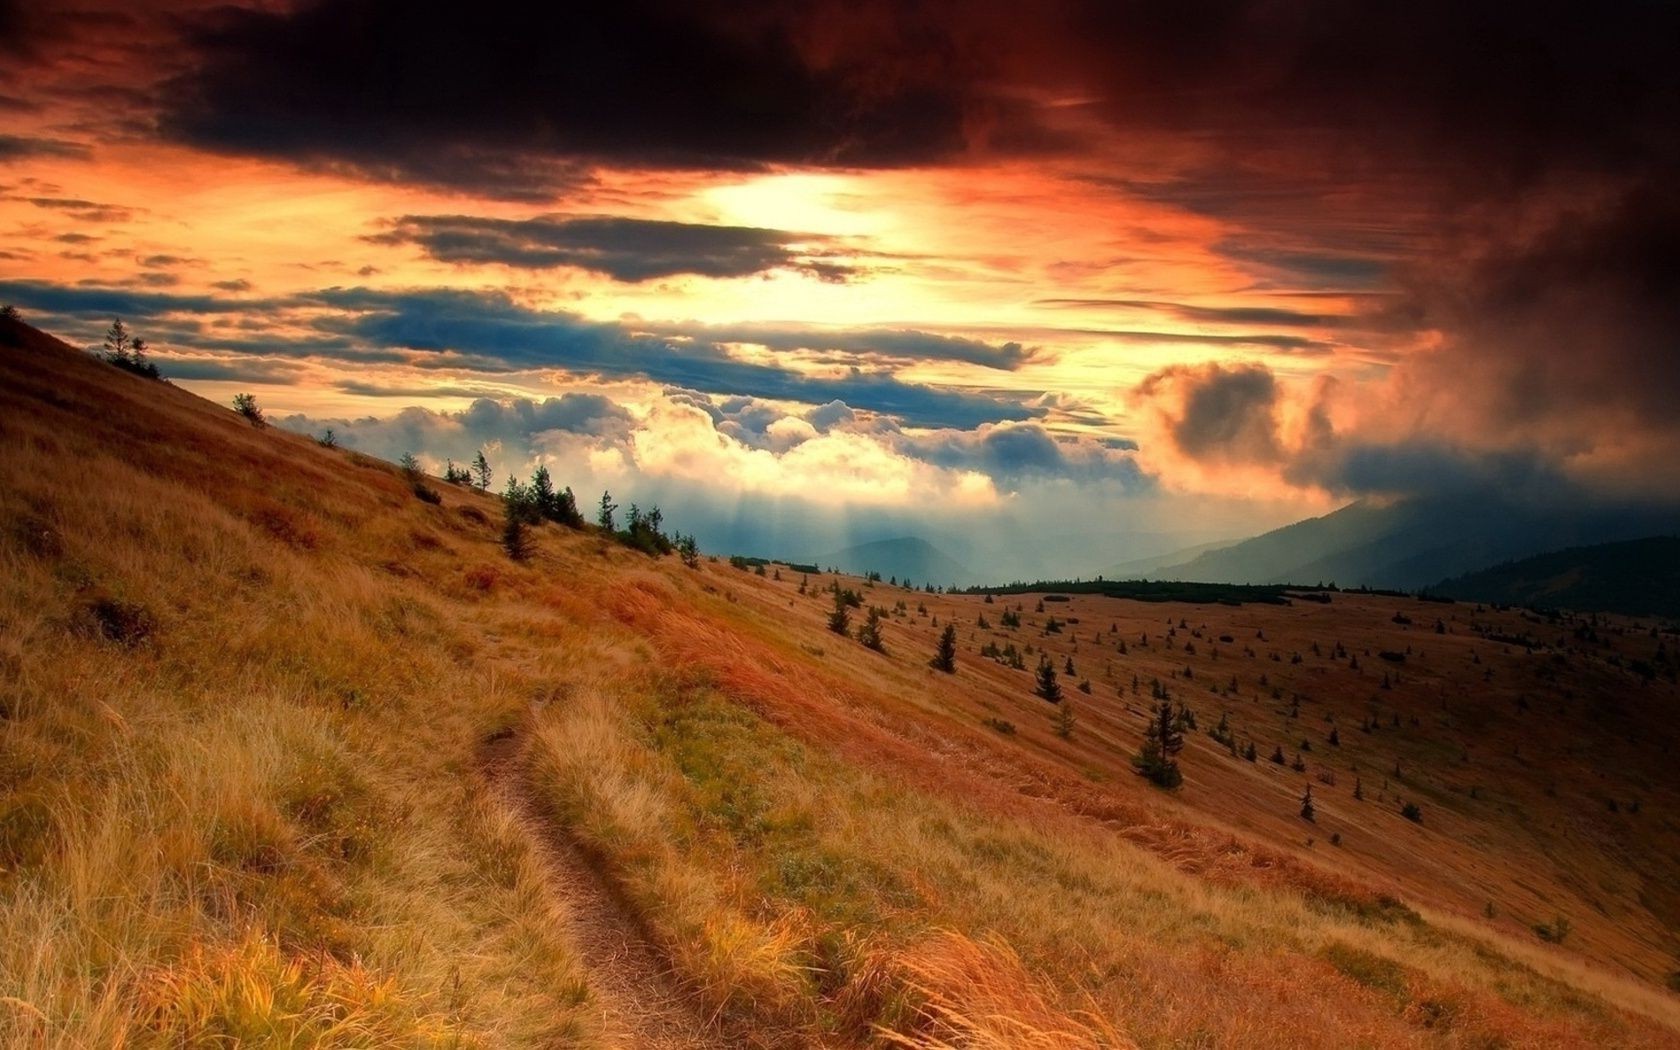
[1430, 536, 1680, 617]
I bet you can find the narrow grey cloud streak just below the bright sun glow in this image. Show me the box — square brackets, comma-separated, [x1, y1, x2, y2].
[381, 215, 850, 282]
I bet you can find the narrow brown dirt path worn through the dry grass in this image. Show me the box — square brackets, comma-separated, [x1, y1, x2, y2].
[480, 732, 731, 1050]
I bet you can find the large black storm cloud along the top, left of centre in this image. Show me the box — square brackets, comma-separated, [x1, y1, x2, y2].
[161, 0, 1018, 198]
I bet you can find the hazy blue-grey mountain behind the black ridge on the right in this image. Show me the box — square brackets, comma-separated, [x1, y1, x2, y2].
[1152, 492, 1680, 590]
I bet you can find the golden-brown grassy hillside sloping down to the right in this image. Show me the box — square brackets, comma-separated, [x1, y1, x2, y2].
[0, 319, 1680, 1048]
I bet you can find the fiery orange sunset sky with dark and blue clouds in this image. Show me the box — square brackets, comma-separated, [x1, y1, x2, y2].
[0, 0, 1680, 578]
